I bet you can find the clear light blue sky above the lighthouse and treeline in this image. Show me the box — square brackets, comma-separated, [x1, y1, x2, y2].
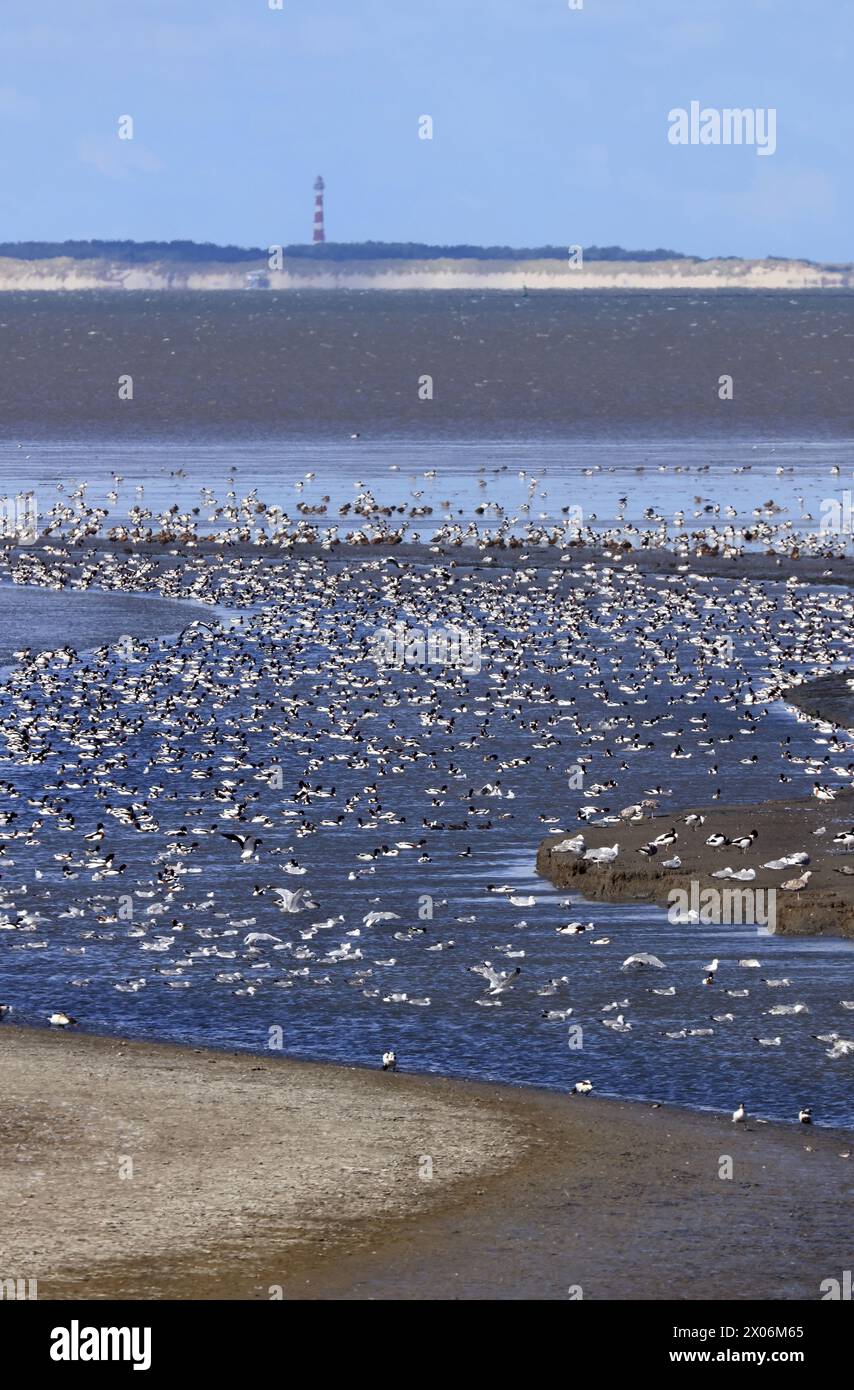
[0, 0, 854, 260]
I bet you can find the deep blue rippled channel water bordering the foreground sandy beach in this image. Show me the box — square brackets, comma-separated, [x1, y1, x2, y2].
[0, 566, 854, 1125]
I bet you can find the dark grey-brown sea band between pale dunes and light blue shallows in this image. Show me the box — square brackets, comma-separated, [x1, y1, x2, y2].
[0, 291, 854, 442]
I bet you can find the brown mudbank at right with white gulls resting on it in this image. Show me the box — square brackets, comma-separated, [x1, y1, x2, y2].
[537, 792, 854, 938]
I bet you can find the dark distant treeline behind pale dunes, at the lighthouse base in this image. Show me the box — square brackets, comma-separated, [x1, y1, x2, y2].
[0, 242, 694, 265]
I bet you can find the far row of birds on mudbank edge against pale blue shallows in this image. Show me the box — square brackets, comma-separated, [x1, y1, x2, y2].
[6, 458, 851, 559]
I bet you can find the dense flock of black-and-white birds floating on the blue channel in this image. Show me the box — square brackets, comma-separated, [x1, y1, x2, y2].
[0, 467, 854, 1123]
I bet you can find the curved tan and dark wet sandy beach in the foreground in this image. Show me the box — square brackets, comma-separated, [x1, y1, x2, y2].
[0, 1026, 854, 1300]
